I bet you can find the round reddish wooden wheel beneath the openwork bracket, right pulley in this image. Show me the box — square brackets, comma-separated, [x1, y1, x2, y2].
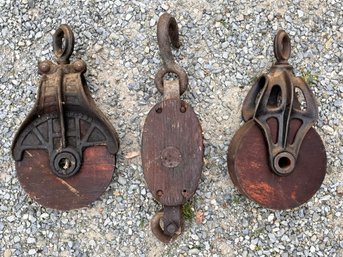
[228, 120, 326, 209]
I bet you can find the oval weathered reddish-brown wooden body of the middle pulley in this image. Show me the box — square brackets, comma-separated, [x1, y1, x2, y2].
[142, 99, 203, 206]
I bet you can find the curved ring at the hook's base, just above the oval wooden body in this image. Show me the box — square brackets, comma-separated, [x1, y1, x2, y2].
[155, 63, 188, 95]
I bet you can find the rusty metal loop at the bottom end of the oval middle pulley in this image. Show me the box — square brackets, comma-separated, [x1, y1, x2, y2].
[150, 206, 183, 244]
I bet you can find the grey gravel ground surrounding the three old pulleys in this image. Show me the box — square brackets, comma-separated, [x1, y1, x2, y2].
[0, 0, 343, 257]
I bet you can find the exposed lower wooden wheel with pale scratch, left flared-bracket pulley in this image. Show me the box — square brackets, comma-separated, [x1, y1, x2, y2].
[16, 146, 115, 210]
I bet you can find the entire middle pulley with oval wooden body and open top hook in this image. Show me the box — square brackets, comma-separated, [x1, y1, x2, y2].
[142, 13, 203, 243]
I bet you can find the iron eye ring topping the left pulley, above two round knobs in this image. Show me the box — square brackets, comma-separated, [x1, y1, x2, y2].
[52, 24, 74, 64]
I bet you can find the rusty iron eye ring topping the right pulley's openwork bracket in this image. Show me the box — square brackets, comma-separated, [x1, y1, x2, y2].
[274, 30, 291, 63]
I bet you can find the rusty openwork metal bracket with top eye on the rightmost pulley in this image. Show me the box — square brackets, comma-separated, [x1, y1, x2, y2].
[242, 30, 318, 176]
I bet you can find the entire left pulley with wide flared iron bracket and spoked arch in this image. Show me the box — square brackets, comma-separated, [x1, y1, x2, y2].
[12, 25, 119, 210]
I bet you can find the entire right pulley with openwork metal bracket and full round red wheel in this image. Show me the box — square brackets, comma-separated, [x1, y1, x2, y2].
[228, 30, 326, 209]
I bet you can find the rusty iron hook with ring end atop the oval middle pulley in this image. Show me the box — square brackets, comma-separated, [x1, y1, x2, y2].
[155, 13, 188, 95]
